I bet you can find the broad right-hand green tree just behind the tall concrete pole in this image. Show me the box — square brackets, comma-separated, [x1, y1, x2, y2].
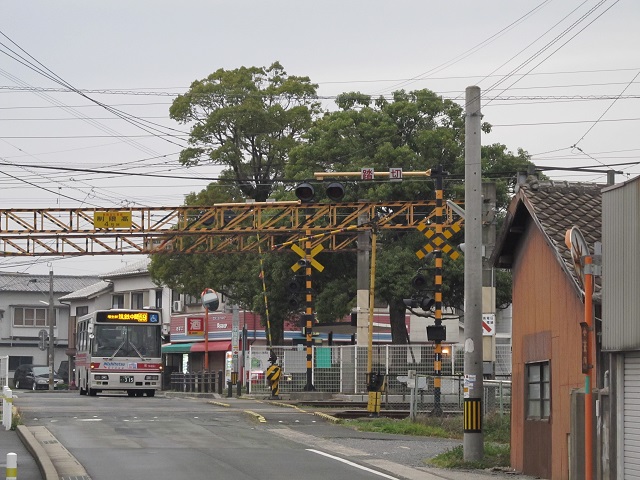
[286, 90, 530, 343]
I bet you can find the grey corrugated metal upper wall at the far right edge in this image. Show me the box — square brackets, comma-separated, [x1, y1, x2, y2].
[602, 177, 640, 351]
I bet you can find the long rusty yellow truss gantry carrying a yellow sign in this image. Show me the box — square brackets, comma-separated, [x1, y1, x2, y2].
[0, 200, 462, 257]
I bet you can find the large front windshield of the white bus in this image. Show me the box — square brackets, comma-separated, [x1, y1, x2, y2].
[93, 325, 161, 359]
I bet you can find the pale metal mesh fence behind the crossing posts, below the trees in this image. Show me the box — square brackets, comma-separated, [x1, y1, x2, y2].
[246, 345, 511, 412]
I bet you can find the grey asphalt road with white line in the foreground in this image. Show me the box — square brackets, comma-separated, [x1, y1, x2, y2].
[16, 392, 457, 480]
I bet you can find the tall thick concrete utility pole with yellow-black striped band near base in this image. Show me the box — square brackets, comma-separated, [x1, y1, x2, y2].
[463, 86, 484, 461]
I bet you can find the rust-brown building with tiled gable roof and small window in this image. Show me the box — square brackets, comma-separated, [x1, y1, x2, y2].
[492, 180, 602, 479]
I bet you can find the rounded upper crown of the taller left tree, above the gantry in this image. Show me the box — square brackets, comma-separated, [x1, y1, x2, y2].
[169, 62, 320, 201]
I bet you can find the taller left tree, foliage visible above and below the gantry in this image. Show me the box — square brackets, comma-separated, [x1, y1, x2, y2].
[150, 62, 320, 343]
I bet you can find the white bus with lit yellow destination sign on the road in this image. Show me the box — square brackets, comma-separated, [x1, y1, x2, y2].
[75, 309, 162, 397]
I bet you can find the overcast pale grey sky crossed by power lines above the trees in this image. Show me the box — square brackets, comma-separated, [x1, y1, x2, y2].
[0, 0, 640, 275]
